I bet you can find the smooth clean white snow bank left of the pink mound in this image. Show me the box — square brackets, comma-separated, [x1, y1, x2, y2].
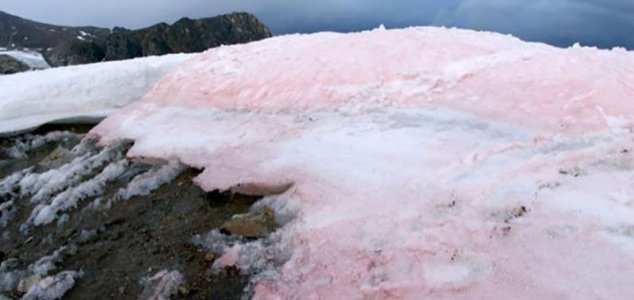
[0, 54, 193, 133]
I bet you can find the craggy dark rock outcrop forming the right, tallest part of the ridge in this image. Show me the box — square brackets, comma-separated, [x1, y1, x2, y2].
[105, 13, 271, 60]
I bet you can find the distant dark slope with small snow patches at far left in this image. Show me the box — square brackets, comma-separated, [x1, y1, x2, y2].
[0, 11, 110, 49]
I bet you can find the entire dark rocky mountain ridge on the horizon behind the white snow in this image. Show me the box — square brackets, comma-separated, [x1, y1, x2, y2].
[0, 11, 271, 67]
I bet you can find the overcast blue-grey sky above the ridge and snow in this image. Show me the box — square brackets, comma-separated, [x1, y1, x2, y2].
[0, 0, 634, 49]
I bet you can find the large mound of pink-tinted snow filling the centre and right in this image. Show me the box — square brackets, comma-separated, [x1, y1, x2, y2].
[92, 28, 634, 299]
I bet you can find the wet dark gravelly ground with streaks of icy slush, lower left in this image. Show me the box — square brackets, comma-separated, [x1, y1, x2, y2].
[0, 123, 277, 299]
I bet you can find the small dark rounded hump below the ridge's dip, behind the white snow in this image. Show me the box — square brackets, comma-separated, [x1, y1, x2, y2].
[44, 40, 106, 67]
